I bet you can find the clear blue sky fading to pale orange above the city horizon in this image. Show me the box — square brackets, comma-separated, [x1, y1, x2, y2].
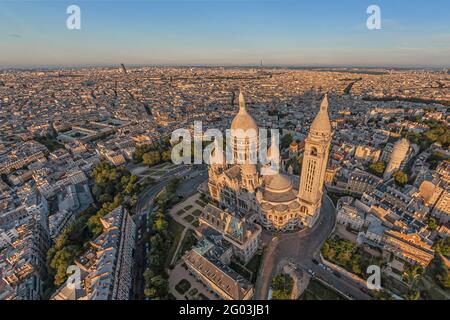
[0, 0, 450, 67]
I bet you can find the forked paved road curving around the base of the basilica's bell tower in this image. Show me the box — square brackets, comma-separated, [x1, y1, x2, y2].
[254, 196, 370, 300]
